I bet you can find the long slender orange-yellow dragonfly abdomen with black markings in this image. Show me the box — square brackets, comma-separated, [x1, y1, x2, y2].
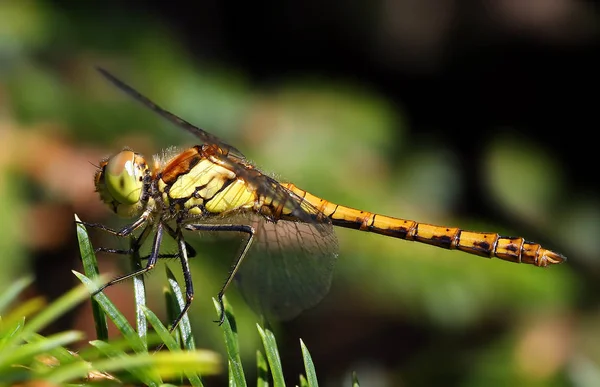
[285, 183, 566, 266]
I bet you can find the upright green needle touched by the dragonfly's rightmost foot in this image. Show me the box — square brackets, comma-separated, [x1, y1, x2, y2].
[213, 298, 246, 387]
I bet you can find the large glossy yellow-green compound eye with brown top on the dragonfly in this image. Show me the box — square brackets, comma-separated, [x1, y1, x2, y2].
[104, 151, 145, 204]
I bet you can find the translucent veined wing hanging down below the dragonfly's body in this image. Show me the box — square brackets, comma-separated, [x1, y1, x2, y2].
[235, 216, 338, 320]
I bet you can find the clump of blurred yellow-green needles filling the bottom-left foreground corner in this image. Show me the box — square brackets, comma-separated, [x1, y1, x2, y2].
[0, 278, 220, 386]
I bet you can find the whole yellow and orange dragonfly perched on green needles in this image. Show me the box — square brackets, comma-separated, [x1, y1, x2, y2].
[86, 68, 566, 331]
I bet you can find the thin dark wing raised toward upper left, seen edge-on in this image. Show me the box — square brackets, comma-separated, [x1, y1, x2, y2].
[96, 67, 245, 160]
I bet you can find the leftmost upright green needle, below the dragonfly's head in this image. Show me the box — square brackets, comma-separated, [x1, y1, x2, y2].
[75, 215, 108, 340]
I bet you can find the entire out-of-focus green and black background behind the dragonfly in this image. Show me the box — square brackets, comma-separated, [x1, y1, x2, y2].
[0, 0, 600, 386]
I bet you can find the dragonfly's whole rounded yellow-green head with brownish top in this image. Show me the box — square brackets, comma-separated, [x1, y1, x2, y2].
[94, 149, 150, 218]
